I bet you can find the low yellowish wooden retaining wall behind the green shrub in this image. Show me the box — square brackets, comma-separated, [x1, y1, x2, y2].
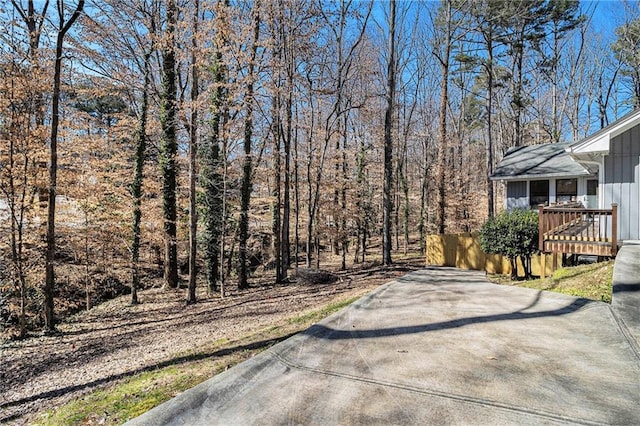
[426, 234, 553, 277]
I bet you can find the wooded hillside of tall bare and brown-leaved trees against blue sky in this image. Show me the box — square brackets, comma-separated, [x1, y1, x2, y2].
[0, 0, 640, 336]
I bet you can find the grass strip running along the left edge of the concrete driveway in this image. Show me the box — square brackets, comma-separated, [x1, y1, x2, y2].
[32, 297, 359, 425]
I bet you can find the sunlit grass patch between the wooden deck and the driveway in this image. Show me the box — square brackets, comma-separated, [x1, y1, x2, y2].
[488, 260, 613, 303]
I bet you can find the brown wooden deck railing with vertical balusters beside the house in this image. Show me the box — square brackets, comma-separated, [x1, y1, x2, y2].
[538, 204, 618, 256]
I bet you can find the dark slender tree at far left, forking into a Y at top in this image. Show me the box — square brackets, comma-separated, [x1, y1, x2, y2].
[44, 0, 84, 331]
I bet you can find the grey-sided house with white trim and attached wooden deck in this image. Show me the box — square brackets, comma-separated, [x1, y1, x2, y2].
[491, 109, 640, 255]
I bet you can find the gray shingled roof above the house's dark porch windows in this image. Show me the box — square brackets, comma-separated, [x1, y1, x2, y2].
[491, 143, 593, 180]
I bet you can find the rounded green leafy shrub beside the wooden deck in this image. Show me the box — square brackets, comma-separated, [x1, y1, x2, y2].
[480, 209, 538, 279]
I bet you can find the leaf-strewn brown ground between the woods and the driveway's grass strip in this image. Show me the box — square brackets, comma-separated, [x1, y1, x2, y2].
[0, 256, 424, 424]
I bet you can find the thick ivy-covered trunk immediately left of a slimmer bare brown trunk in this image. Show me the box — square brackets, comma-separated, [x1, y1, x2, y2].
[160, 0, 178, 288]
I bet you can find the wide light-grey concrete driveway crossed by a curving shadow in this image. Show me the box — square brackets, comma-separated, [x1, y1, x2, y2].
[126, 268, 640, 425]
